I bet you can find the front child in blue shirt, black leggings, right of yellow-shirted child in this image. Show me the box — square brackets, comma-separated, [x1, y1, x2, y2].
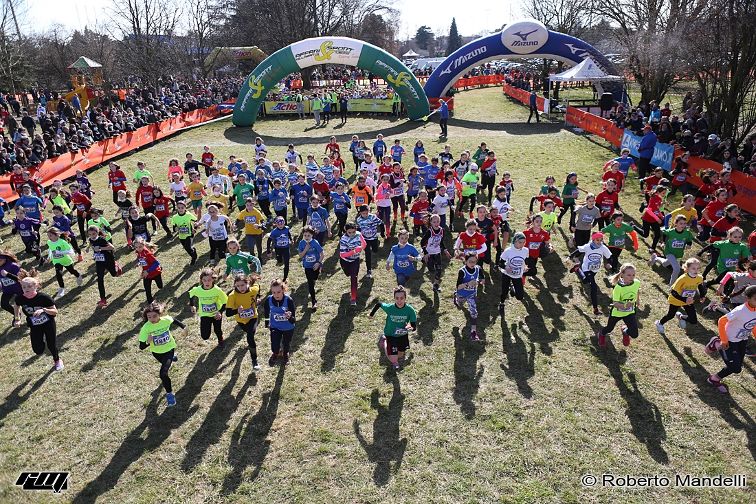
[262, 279, 296, 367]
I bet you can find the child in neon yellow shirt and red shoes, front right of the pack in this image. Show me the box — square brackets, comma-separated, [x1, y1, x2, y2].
[596, 263, 640, 348]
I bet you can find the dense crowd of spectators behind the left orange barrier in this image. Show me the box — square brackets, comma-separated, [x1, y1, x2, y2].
[0, 77, 243, 174]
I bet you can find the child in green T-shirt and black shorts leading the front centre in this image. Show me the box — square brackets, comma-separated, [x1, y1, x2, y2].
[369, 285, 417, 371]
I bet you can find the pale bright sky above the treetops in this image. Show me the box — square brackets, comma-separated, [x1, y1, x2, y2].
[25, 0, 520, 39]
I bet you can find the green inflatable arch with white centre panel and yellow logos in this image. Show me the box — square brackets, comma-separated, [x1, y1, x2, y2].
[233, 37, 430, 126]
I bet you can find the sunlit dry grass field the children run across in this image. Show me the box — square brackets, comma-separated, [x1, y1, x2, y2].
[0, 88, 756, 503]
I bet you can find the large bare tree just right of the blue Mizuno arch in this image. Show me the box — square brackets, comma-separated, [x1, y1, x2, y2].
[593, 0, 711, 102]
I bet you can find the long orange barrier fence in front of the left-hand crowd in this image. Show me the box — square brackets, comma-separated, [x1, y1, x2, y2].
[0, 105, 227, 202]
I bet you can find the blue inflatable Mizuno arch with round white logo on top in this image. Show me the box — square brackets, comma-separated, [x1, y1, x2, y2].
[425, 19, 625, 101]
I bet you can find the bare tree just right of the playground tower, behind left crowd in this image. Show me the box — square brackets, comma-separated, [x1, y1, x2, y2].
[112, 0, 181, 85]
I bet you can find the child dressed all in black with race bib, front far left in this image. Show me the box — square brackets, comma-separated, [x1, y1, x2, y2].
[13, 276, 63, 371]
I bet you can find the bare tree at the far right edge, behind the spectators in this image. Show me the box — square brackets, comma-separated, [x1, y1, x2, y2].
[683, 0, 756, 142]
